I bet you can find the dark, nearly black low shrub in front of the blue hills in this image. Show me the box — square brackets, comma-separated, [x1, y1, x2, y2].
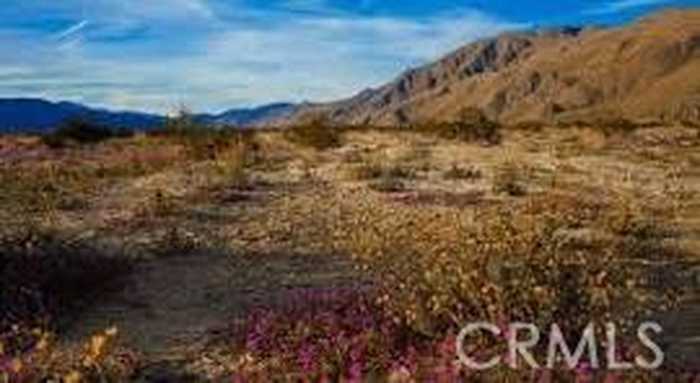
[41, 118, 132, 148]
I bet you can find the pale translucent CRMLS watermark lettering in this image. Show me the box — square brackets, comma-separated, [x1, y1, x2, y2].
[457, 322, 665, 370]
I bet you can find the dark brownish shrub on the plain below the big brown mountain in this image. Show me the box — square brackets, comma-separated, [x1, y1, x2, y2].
[418, 108, 503, 145]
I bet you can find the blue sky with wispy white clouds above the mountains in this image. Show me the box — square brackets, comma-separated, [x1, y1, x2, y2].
[0, 0, 700, 113]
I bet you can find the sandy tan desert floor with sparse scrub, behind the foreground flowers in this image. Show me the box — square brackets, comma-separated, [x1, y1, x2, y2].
[0, 127, 700, 380]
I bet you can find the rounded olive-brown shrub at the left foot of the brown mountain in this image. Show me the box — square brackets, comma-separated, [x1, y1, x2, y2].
[285, 115, 341, 150]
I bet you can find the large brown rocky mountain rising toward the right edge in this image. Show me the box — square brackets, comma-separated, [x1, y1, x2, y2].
[287, 10, 700, 125]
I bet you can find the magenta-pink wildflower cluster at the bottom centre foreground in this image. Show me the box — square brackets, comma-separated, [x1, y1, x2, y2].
[234, 288, 459, 382]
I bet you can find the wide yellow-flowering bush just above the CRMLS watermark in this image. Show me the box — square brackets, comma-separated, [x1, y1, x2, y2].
[347, 192, 678, 356]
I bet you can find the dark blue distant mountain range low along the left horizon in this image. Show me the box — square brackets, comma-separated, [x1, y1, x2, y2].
[0, 98, 297, 133]
